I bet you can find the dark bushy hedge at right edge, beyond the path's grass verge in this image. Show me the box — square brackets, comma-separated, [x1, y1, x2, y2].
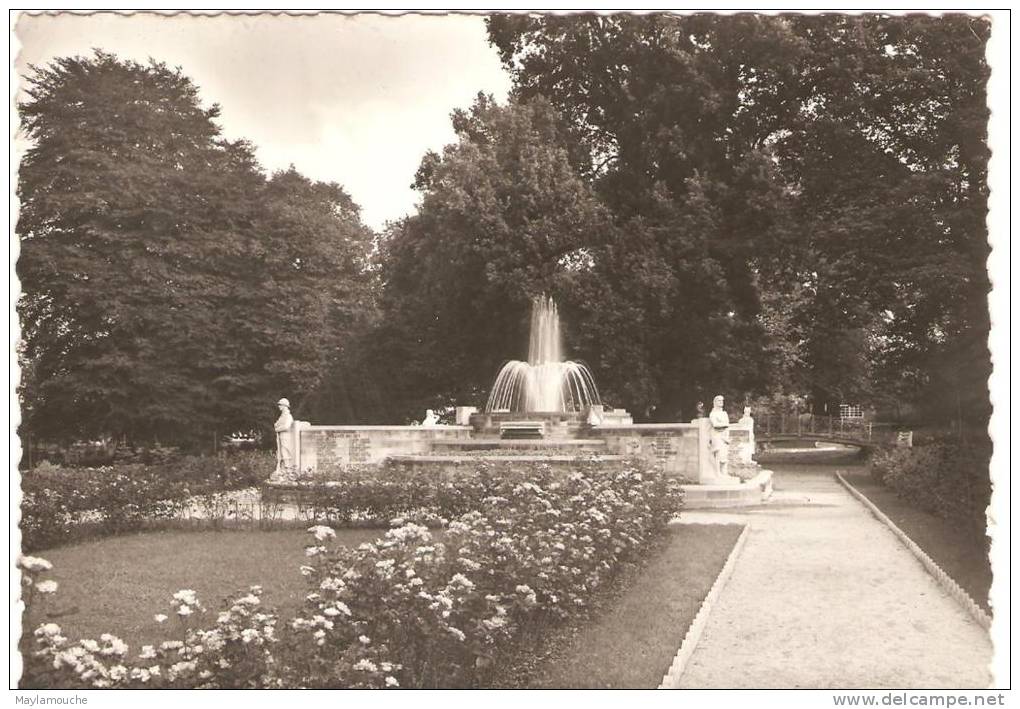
[871, 437, 991, 533]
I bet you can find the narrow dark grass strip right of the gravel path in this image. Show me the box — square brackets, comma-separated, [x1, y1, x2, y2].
[843, 469, 991, 610]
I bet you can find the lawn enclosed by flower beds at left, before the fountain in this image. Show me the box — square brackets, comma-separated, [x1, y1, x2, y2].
[33, 529, 384, 650]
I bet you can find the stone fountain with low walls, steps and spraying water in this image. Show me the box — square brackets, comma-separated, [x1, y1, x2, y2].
[274, 296, 771, 507]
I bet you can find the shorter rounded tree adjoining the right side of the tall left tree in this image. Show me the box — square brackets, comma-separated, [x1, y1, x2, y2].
[259, 167, 379, 423]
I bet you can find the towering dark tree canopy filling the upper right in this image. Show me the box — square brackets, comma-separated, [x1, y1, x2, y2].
[489, 15, 988, 422]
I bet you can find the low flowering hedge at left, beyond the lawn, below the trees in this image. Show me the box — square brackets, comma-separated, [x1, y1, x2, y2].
[20, 452, 273, 552]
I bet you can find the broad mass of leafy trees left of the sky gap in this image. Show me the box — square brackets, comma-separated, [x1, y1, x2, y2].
[17, 52, 371, 440]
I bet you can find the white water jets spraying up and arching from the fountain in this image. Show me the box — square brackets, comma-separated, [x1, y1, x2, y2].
[486, 296, 602, 413]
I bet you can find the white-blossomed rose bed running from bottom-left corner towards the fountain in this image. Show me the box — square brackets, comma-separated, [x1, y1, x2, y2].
[22, 465, 682, 688]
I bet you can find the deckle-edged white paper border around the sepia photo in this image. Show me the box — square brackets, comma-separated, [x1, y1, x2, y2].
[7, 8, 1013, 706]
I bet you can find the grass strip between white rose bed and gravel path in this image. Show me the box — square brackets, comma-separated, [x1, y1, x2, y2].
[497, 524, 742, 689]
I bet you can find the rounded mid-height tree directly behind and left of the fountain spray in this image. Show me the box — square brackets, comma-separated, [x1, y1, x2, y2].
[374, 95, 608, 417]
